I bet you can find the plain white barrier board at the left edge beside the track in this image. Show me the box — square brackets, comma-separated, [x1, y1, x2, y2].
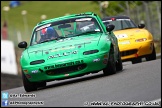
[1, 40, 18, 75]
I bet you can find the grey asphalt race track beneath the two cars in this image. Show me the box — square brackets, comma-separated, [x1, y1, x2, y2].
[1, 58, 161, 107]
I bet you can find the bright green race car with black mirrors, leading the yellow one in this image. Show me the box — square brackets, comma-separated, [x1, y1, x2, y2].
[18, 12, 123, 92]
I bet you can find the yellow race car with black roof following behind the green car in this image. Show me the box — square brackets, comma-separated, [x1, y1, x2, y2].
[102, 16, 156, 64]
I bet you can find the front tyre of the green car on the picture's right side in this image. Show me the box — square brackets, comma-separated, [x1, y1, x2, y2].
[103, 48, 116, 75]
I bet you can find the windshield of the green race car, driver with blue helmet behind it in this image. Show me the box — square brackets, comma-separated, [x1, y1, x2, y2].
[30, 17, 103, 46]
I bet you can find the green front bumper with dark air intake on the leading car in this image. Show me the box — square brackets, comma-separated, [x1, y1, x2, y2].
[23, 53, 108, 82]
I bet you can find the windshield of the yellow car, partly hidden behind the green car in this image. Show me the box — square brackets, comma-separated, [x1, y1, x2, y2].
[103, 19, 137, 31]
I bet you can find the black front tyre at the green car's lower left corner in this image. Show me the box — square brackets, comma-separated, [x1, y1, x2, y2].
[22, 72, 37, 92]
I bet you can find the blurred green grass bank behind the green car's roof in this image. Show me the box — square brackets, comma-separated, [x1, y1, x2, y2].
[1, 1, 100, 44]
